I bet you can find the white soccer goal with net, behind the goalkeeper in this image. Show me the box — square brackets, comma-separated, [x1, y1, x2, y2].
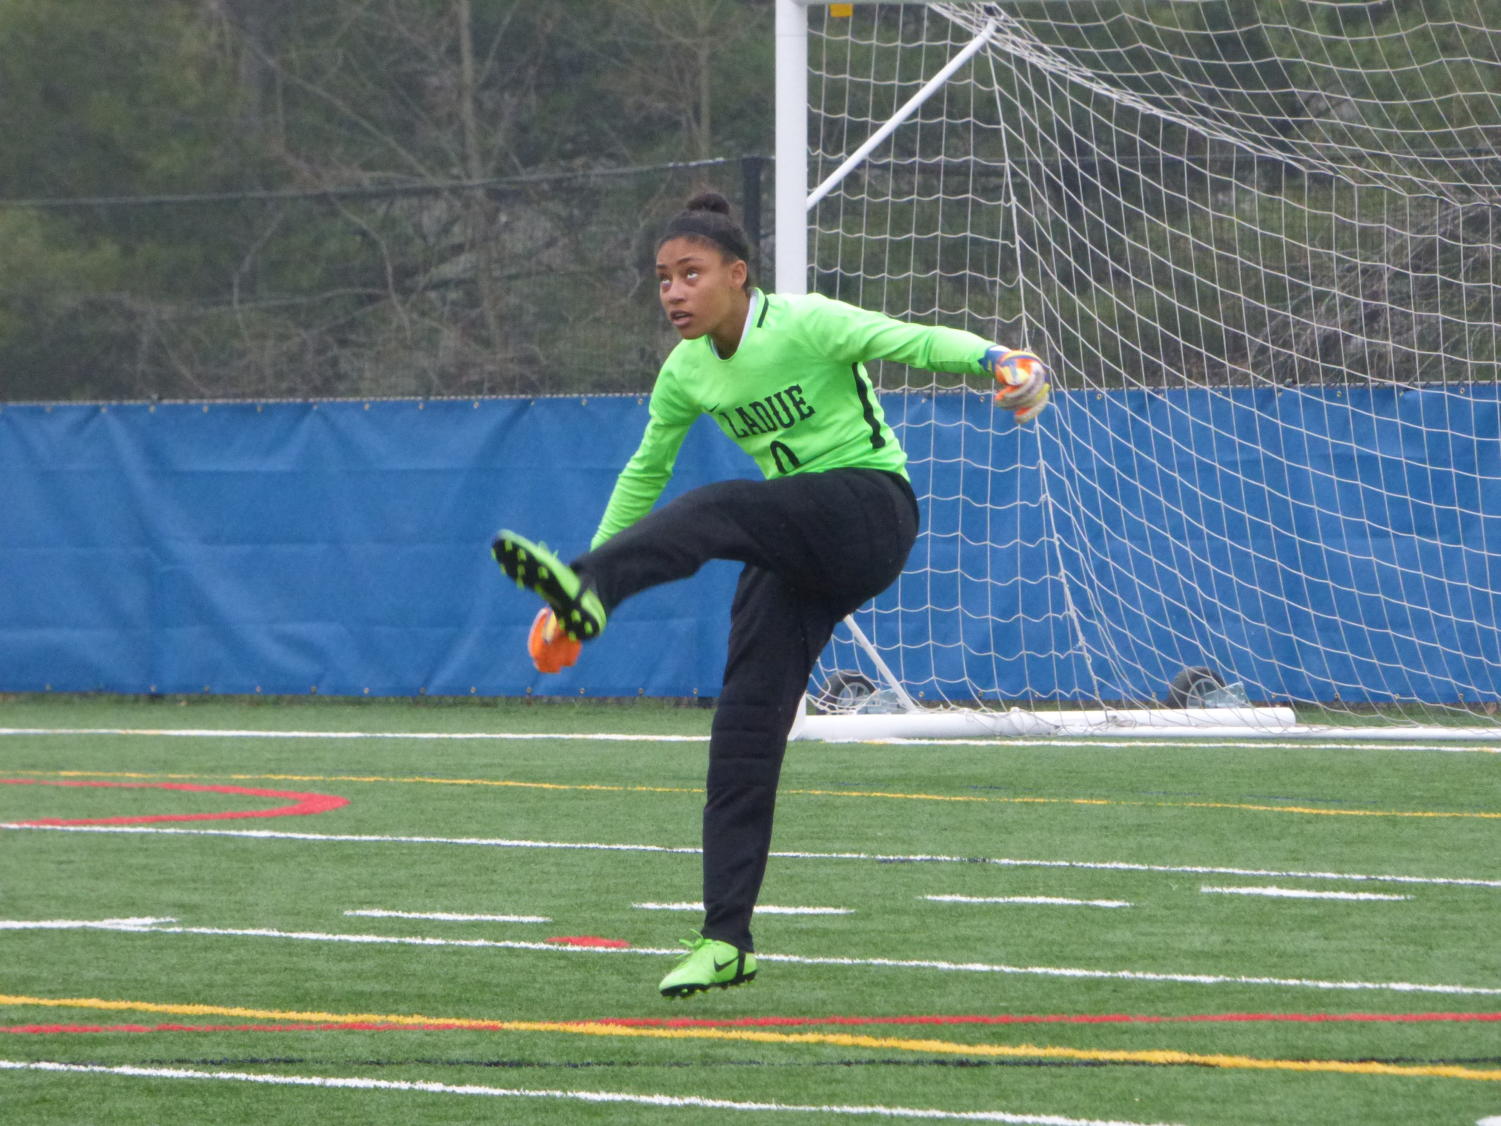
[776, 0, 1501, 739]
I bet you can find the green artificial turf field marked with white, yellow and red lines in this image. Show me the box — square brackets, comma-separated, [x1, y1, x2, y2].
[0, 698, 1501, 1126]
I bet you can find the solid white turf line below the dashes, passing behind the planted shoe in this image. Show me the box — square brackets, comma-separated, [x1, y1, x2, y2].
[11, 923, 1501, 997]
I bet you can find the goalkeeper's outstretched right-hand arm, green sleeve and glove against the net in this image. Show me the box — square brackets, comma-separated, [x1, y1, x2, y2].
[809, 297, 1049, 422]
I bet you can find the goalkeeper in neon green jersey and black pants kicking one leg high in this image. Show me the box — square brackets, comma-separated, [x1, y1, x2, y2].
[492, 192, 1048, 997]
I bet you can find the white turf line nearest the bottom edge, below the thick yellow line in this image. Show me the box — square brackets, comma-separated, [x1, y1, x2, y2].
[0, 1060, 1176, 1126]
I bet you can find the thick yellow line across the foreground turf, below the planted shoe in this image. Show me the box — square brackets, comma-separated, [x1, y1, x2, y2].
[0, 994, 1501, 1082]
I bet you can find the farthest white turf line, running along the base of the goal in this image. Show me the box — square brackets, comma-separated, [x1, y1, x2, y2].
[0, 727, 1501, 755]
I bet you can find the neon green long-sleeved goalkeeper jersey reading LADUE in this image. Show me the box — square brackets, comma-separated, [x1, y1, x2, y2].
[591, 290, 991, 548]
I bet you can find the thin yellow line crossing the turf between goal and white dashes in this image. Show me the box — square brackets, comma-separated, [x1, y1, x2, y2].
[9, 770, 1501, 821]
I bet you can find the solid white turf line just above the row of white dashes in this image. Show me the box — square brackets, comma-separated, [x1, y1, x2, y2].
[0, 823, 1501, 889]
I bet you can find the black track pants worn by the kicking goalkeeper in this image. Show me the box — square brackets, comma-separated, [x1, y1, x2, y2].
[573, 468, 917, 950]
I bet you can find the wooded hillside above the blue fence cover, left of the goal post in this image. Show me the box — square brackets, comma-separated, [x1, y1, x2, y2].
[0, 0, 772, 399]
